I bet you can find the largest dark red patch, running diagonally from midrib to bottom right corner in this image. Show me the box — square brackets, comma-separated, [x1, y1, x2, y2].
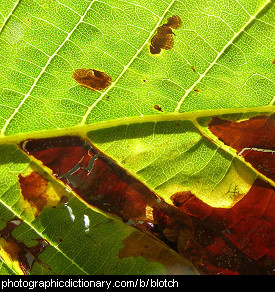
[21, 136, 275, 274]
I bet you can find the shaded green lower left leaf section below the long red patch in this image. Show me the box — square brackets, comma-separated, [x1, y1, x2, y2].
[0, 143, 197, 275]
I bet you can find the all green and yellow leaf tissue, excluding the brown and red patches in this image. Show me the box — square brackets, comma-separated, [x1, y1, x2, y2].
[0, 0, 275, 274]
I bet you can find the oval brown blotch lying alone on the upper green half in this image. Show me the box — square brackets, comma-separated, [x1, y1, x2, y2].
[73, 69, 112, 90]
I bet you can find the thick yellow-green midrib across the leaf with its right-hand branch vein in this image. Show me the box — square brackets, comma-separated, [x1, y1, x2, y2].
[0, 106, 275, 191]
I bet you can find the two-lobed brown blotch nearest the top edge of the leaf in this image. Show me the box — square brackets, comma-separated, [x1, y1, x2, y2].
[150, 15, 182, 55]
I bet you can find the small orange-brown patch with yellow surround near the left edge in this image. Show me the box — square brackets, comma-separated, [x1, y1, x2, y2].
[18, 172, 48, 215]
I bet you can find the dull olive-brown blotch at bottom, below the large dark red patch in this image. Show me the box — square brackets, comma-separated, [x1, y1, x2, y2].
[119, 231, 194, 275]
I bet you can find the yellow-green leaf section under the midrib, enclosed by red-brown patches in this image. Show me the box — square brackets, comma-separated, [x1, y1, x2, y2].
[88, 114, 272, 207]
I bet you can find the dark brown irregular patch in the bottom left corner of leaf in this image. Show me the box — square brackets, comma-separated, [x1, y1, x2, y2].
[0, 218, 49, 275]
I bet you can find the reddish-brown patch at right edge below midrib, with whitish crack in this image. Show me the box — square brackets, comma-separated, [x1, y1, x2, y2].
[209, 114, 275, 180]
